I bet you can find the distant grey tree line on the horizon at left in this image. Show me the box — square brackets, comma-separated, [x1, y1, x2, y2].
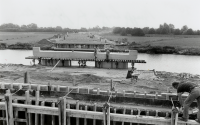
[0, 23, 87, 32]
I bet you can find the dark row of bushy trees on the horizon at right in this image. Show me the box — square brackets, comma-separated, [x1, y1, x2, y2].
[113, 23, 200, 36]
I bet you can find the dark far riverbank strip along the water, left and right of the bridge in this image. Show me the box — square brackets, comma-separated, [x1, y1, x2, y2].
[0, 43, 200, 55]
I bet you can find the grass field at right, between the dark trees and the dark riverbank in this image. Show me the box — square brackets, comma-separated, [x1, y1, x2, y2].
[101, 33, 200, 48]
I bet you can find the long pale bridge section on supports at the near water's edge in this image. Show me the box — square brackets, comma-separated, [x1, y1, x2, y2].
[26, 47, 146, 69]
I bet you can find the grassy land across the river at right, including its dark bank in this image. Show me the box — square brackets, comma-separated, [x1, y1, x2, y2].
[101, 33, 200, 55]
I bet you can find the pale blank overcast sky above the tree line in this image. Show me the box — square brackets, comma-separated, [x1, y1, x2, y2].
[0, 0, 200, 30]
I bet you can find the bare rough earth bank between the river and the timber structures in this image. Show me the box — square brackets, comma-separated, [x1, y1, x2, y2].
[0, 64, 200, 93]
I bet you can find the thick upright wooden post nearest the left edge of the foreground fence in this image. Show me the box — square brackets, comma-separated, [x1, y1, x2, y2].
[5, 93, 14, 125]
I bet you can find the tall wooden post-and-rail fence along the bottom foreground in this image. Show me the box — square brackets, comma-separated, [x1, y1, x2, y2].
[0, 91, 198, 125]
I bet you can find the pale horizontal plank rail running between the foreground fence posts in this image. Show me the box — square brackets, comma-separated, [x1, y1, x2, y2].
[10, 104, 198, 125]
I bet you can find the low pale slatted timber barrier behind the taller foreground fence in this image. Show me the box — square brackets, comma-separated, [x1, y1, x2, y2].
[0, 80, 187, 100]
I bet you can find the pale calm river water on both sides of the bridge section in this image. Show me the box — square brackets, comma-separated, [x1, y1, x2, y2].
[0, 50, 200, 75]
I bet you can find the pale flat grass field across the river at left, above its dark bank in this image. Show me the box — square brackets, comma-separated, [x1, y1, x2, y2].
[0, 32, 57, 44]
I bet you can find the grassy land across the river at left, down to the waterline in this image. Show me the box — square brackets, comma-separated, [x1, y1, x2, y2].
[0, 32, 57, 49]
